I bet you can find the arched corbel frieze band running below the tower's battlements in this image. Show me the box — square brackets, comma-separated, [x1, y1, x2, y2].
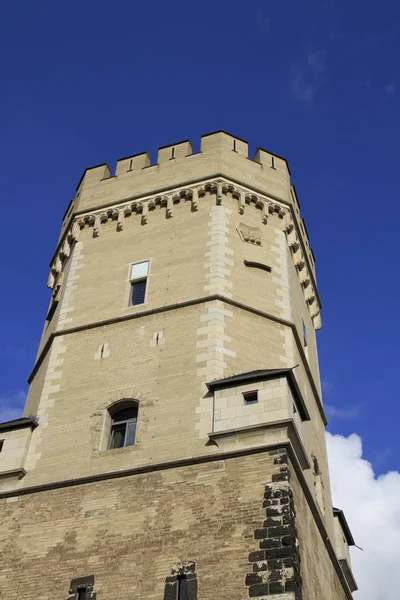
[47, 177, 321, 329]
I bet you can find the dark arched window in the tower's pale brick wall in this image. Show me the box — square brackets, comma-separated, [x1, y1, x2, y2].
[108, 400, 138, 450]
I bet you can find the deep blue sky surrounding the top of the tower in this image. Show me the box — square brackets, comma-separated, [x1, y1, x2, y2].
[0, 0, 400, 473]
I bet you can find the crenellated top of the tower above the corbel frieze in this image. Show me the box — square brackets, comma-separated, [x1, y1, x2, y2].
[74, 131, 293, 213]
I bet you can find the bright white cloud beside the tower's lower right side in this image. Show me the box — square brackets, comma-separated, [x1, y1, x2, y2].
[327, 433, 400, 600]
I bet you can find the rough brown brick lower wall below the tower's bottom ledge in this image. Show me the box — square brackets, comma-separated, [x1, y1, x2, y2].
[0, 450, 344, 600]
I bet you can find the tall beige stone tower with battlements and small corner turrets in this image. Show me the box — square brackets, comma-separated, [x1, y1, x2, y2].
[0, 131, 356, 600]
